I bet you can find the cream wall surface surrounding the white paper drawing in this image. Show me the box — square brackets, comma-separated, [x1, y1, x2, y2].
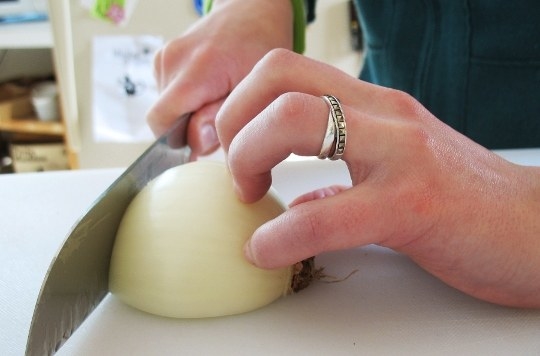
[49, 0, 197, 168]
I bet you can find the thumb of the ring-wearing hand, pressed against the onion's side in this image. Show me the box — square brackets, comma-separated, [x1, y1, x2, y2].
[244, 187, 384, 269]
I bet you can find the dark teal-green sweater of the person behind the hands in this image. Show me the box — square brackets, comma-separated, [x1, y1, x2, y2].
[355, 0, 540, 148]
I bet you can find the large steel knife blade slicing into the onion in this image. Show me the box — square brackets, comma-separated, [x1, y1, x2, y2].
[26, 115, 191, 356]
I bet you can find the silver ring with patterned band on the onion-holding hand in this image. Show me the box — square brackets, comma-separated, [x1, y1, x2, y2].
[318, 95, 347, 161]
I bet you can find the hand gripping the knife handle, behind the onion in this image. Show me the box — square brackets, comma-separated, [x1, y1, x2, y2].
[147, 0, 293, 156]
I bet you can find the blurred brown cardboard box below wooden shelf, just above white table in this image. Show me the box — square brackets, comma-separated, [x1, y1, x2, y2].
[10, 143, 69, 173]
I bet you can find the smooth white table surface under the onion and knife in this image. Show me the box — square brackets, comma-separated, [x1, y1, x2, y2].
[0, 149, 540, 356]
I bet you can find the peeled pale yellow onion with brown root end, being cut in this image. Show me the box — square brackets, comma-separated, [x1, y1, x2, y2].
[109, 161, 313, 318]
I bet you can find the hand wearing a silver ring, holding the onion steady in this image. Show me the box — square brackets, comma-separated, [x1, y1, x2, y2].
[217, 50, 540, 307]
